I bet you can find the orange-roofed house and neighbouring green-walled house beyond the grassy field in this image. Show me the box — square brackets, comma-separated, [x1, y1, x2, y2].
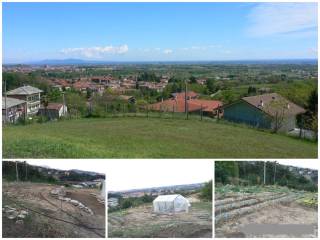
[149, 91, 306, 132]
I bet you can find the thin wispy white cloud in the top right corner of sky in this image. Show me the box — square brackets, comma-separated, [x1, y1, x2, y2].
[247, 3, 318, 37]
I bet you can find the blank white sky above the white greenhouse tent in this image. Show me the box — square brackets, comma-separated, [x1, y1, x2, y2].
[106, 159, 214, 191]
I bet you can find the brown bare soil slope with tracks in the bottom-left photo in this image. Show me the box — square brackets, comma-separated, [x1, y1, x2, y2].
[2, 182, 105, 238]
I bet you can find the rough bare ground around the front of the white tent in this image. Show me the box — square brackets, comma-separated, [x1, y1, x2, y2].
[108, 202, 212, 238]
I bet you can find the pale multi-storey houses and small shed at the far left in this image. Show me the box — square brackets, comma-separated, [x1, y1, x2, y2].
[2, 86, 68, 123]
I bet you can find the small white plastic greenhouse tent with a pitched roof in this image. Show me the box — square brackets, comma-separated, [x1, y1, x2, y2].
[153, 194, 191, 213]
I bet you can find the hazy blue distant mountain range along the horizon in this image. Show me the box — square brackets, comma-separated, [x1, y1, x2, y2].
[16, 58, 318, 65]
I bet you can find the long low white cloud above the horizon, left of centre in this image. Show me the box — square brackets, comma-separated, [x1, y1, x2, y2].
[61, 44, 129, 58]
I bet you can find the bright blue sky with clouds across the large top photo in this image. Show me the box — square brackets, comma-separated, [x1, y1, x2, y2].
[2, 3, 318, 63]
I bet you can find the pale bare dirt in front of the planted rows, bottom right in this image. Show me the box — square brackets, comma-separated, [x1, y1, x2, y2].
[215, 203, 318, 238]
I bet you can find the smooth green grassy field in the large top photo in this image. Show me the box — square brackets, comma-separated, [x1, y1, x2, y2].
[3, 117, 317, 158]
